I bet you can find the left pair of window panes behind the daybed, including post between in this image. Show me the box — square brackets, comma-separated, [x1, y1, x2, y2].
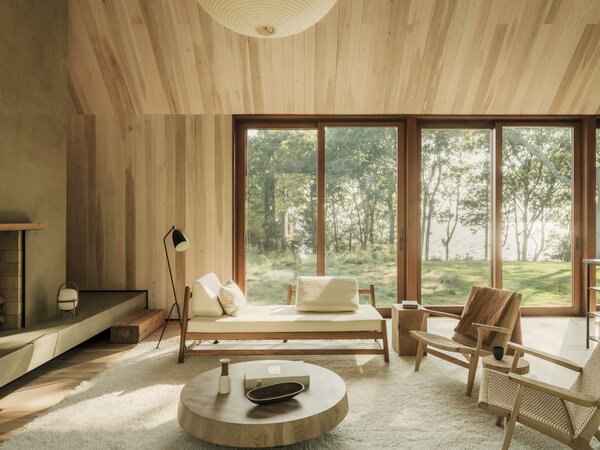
[237, 123, 398, 306]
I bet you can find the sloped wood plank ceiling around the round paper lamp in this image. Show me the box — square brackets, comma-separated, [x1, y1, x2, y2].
[68, 0, 600, 114]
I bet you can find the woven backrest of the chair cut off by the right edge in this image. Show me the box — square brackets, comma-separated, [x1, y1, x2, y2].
[565, 345, 600, 435]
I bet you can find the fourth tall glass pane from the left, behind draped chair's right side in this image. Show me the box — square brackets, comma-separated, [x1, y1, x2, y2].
[502, 127, 573, 306]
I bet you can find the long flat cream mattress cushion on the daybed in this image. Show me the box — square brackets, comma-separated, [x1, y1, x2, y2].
[188, 305, 382, 333]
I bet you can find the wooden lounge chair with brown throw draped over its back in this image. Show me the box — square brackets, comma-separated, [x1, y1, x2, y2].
[410, 286, 521, 396]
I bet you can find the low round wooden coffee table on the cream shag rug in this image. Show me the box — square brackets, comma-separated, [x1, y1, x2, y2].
[177, 361, 348, 447]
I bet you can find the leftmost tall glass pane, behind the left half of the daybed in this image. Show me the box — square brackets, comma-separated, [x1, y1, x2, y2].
[246, 129, 317, 304]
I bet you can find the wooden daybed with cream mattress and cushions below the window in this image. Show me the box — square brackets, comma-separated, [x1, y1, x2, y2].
[179, 274, 389, 363]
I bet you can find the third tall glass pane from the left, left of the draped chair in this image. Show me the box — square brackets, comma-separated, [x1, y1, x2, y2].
[418, 128, 492, 305]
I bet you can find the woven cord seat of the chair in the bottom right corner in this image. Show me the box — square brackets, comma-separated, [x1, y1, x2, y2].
[479, 369, 574, 438]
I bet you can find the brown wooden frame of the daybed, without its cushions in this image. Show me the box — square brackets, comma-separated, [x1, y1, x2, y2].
[178, 285, 390, 363]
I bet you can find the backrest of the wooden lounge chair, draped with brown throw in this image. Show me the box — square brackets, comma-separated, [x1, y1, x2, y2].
[452, 286, 522, 349]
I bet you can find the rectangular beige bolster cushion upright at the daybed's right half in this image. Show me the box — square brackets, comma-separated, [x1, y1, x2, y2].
[296, 277, 358, 312]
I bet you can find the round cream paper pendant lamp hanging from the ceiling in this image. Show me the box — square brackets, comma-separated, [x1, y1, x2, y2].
[198, 0, 337, 38]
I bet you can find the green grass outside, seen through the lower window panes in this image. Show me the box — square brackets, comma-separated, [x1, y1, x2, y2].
[247, 253, 571, 306]
